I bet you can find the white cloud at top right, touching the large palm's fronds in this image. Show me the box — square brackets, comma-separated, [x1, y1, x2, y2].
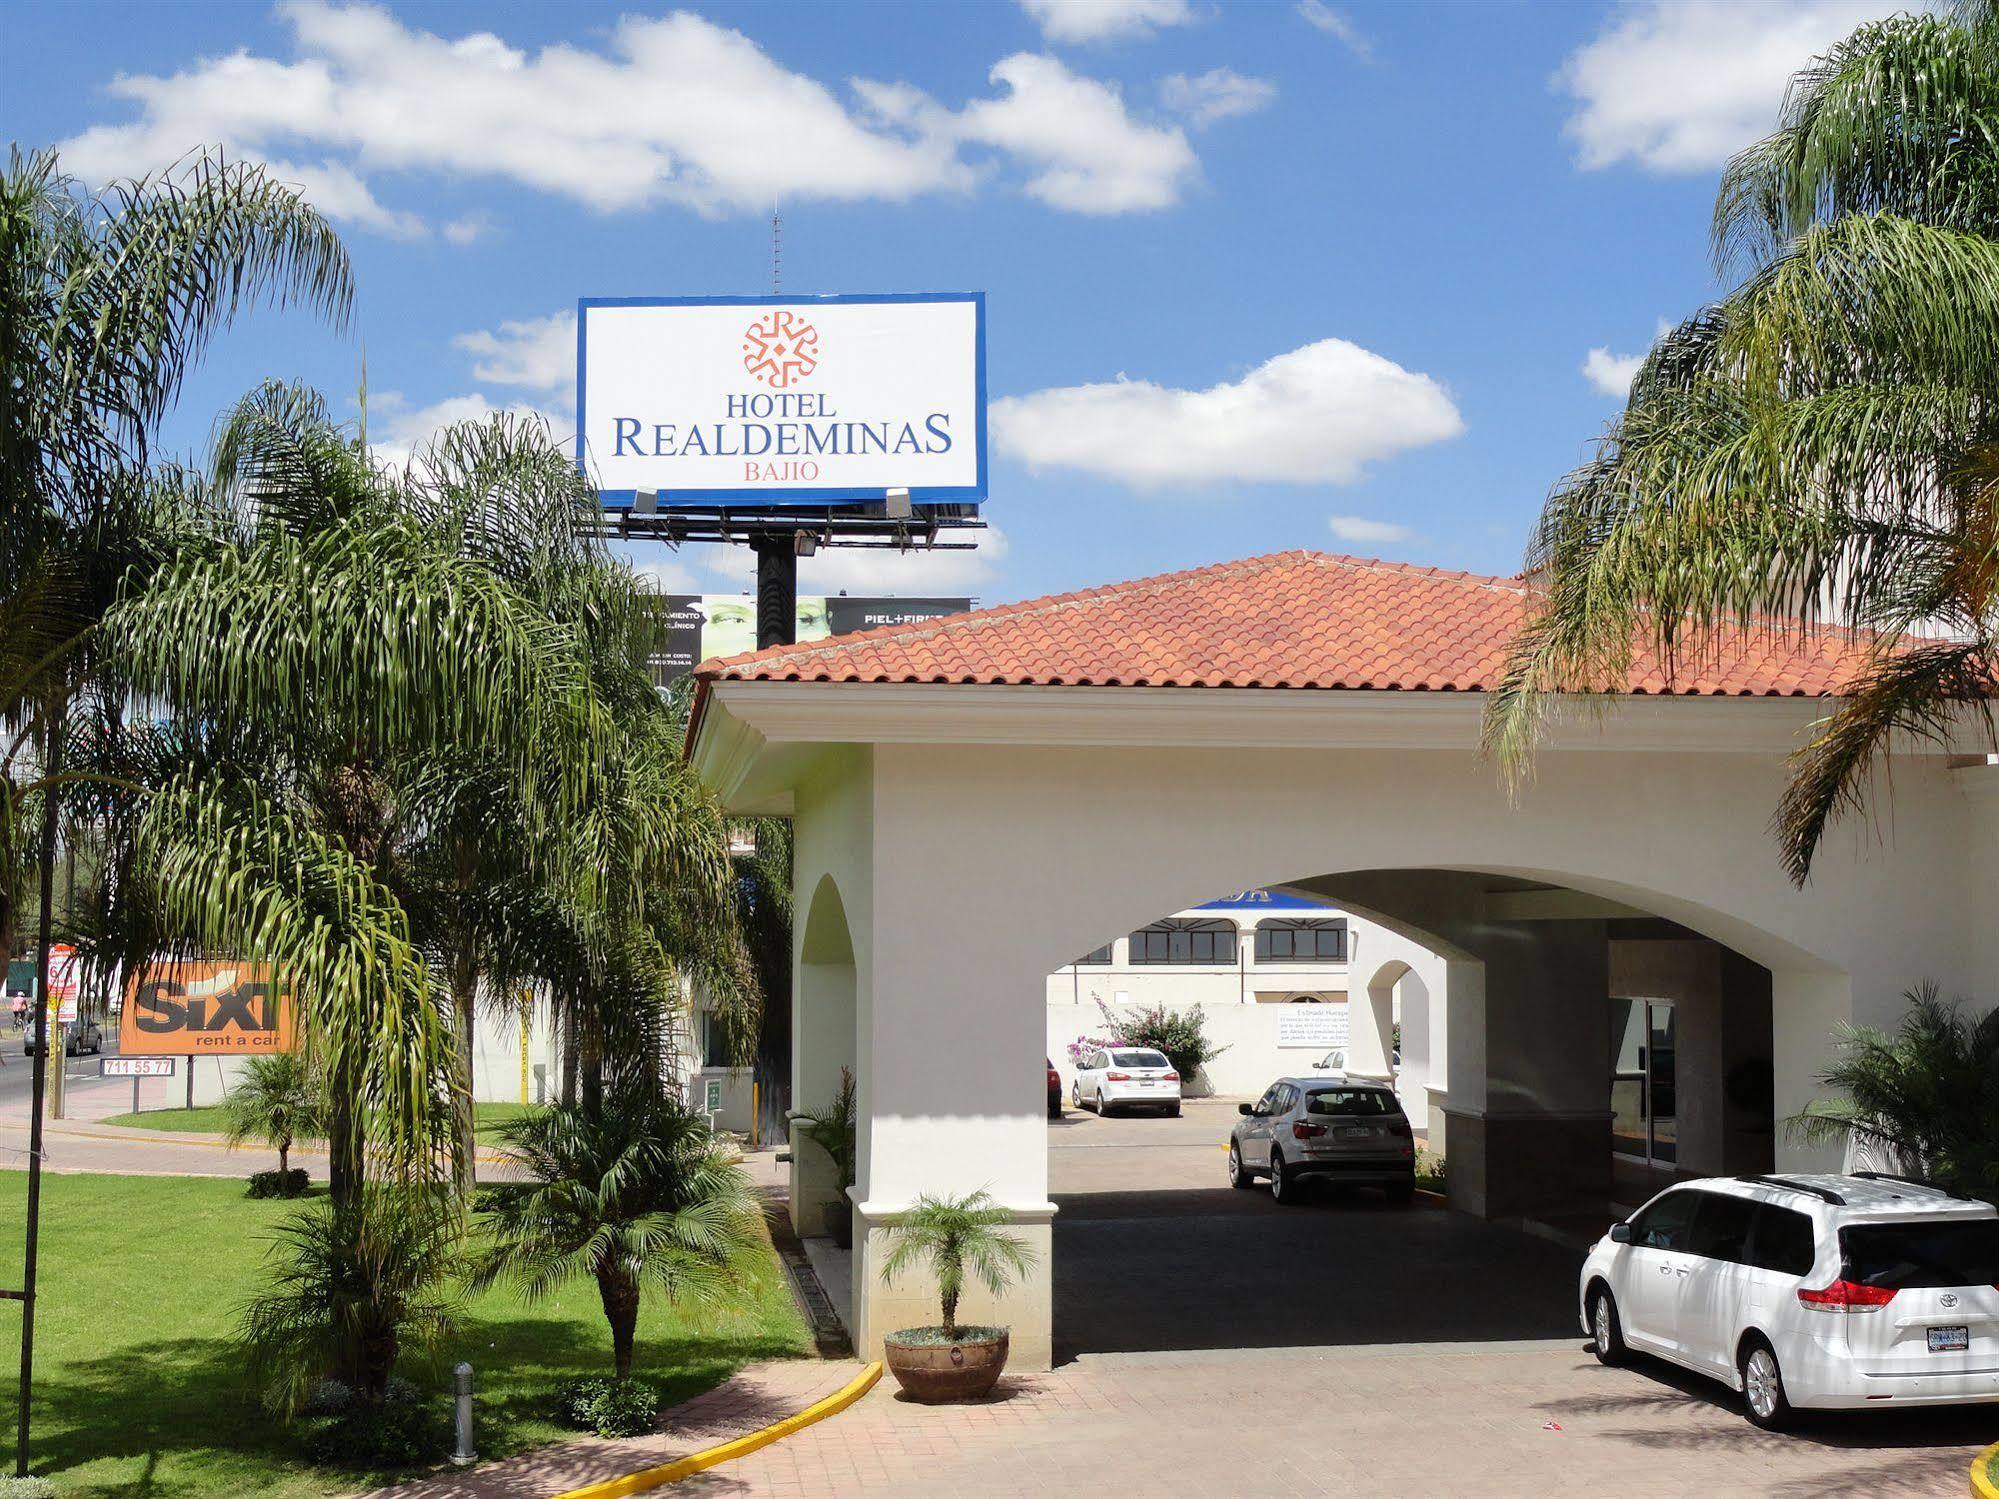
[1555, 0, 1899, 172]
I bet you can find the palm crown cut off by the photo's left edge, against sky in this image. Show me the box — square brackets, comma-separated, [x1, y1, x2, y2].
[0, 148, 354, 979]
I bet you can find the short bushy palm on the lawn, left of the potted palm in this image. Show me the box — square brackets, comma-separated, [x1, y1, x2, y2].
[474, 1075, 764, 1379]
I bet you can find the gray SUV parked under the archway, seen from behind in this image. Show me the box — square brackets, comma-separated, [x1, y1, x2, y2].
[1229, 1075, 1415, 1207]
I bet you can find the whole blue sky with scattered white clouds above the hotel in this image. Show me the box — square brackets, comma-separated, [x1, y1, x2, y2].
[0, 0, 1893, 602]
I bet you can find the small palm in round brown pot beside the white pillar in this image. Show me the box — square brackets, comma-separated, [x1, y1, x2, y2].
[882, 1191, 1033, 1405]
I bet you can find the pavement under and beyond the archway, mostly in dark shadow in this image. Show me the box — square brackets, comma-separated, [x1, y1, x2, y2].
[1047, 1099, 1581, 1363]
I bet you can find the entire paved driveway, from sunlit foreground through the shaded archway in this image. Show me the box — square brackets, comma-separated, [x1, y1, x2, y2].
[680, 1103, 1999, 1499]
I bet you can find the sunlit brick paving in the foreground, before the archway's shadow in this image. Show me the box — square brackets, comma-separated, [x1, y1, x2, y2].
[676, 1339, 1999, 1499]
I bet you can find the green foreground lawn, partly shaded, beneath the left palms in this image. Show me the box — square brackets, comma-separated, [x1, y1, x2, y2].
[0, 1171, 810, 1499]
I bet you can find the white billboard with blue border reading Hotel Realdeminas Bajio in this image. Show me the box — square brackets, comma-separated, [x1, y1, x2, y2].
[576, 292, 986, 512]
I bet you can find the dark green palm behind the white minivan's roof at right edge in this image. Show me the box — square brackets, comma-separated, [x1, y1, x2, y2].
[1789, 983, 1999, 1201]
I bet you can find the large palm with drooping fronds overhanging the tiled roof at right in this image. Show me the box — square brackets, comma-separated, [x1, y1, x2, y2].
[1485, 0, 1999, 883]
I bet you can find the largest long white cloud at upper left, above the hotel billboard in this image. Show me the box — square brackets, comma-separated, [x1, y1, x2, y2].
[60, 0, 1197, 231]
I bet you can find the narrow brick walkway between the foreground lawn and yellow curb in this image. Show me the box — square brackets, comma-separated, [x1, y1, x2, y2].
[368, 1359, 862, 1499]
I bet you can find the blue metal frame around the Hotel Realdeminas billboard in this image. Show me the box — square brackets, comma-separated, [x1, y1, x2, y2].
[576, 292, 988, 515]
